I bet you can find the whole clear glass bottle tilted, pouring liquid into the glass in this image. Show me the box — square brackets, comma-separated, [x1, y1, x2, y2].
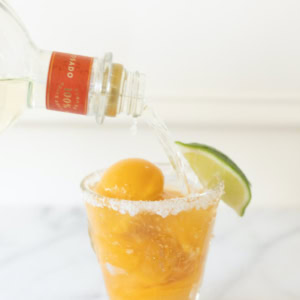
[0, 0, 145, 132]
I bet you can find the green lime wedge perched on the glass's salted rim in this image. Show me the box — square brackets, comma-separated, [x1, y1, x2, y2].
[176, 142, 251, 216]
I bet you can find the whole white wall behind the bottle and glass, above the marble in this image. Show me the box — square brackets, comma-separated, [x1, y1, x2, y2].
[0, 0, 300, 209]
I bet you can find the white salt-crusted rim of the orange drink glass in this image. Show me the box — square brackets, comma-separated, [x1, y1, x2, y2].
[80, 168, 224, 217]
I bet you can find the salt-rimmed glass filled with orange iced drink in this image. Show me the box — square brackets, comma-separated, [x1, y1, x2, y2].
[81, 164, 223, 300]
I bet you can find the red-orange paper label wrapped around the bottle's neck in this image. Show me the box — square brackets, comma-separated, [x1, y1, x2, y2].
[46, 52, 93, 115]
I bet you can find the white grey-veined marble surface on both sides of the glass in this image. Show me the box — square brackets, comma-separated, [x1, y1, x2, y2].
[0, 206, 300, 300]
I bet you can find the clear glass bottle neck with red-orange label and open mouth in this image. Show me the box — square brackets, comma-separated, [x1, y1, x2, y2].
[28, 51, 145, 124]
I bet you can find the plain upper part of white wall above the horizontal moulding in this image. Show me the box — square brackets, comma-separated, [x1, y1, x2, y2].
[9, 0, 300, 99]
